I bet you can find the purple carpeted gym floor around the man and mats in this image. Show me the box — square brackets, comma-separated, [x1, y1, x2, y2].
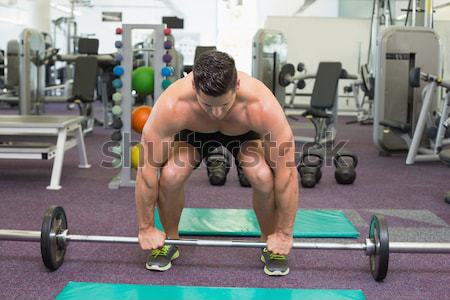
[0, 106, 450, 300]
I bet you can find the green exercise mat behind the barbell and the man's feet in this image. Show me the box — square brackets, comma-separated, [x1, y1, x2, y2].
[155, 208, 359, 238]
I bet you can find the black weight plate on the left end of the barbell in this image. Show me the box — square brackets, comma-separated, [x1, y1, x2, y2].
[41, 206, 67, 271]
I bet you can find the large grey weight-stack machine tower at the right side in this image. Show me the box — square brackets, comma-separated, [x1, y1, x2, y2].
[373, 27, 442, 155]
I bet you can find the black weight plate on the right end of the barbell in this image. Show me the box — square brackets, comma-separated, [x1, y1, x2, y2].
[369, 215, 389, 281]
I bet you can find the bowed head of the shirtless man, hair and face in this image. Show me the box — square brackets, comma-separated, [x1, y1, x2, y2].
[193, 51, 239, 120]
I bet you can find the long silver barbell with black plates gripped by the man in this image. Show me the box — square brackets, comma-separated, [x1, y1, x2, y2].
[0, 206, 450, 281]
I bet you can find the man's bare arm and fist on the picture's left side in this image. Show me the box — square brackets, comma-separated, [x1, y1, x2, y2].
[135, 98, 179, 249]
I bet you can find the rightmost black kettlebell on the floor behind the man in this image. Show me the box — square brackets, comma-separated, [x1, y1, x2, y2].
[333, 149, 358, 184]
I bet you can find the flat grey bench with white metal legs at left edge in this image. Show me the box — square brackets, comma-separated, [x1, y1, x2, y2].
[0, 116, 90, 190]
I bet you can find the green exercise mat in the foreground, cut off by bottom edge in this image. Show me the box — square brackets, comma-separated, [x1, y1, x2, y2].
[56, 282, 366, 300]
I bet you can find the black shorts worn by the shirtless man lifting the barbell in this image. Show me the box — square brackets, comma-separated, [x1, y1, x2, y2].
[175, 129, 261, 160]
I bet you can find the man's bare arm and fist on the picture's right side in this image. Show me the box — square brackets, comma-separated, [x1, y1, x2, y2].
[253, 85, 299, 254]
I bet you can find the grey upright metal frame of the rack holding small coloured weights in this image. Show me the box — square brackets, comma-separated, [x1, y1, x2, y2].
[108, 24, 166, 189]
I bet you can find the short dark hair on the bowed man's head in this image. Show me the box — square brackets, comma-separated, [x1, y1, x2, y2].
[193, 51, 237, 97]
